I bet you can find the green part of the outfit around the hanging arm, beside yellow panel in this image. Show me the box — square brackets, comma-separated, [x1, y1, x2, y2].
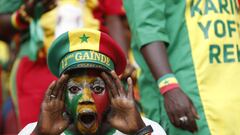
[124, 0, 210, 135]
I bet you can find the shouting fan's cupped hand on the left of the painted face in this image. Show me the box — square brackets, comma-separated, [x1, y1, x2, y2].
[34, 75, 70, 135]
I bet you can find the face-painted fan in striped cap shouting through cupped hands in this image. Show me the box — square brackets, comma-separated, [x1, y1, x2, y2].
[21, 29, 162, 135]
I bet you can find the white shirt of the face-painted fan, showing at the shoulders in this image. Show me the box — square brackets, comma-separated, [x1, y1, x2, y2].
[18, 117, 166, 135]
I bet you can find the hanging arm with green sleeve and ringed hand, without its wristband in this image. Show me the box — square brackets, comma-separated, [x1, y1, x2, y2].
[124, 0, 198, 132]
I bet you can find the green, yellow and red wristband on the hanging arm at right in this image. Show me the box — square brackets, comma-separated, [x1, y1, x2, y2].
[157, 73, 179, 95]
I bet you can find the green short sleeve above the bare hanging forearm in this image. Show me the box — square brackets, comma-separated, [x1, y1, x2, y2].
[124, 0, 169, 49]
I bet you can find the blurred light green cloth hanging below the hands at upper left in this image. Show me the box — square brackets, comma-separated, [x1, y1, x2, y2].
[29, 3, 44, 61]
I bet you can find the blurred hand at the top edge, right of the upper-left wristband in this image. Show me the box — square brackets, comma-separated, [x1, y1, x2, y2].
[25, 0, 57, 17]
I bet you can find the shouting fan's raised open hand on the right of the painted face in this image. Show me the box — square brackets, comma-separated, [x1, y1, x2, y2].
[102, 71, 145, 134]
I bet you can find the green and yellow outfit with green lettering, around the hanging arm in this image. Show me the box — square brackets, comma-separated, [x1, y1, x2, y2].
[124, 0, 240, 135]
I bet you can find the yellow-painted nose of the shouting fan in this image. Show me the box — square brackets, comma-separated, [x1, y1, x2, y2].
[78, 88, 94, 105]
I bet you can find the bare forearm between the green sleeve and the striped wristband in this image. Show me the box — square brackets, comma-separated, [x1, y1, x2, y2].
[141, 41, 172, 80]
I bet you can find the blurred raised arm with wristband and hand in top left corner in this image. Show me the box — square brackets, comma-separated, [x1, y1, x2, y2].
[0, 0, 56, 41]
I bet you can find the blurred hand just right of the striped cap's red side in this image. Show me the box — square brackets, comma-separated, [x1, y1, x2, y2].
[120, 61, 137, 84]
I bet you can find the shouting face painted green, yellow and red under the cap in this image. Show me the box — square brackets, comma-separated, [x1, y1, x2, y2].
[66, 72, 109, 134]
